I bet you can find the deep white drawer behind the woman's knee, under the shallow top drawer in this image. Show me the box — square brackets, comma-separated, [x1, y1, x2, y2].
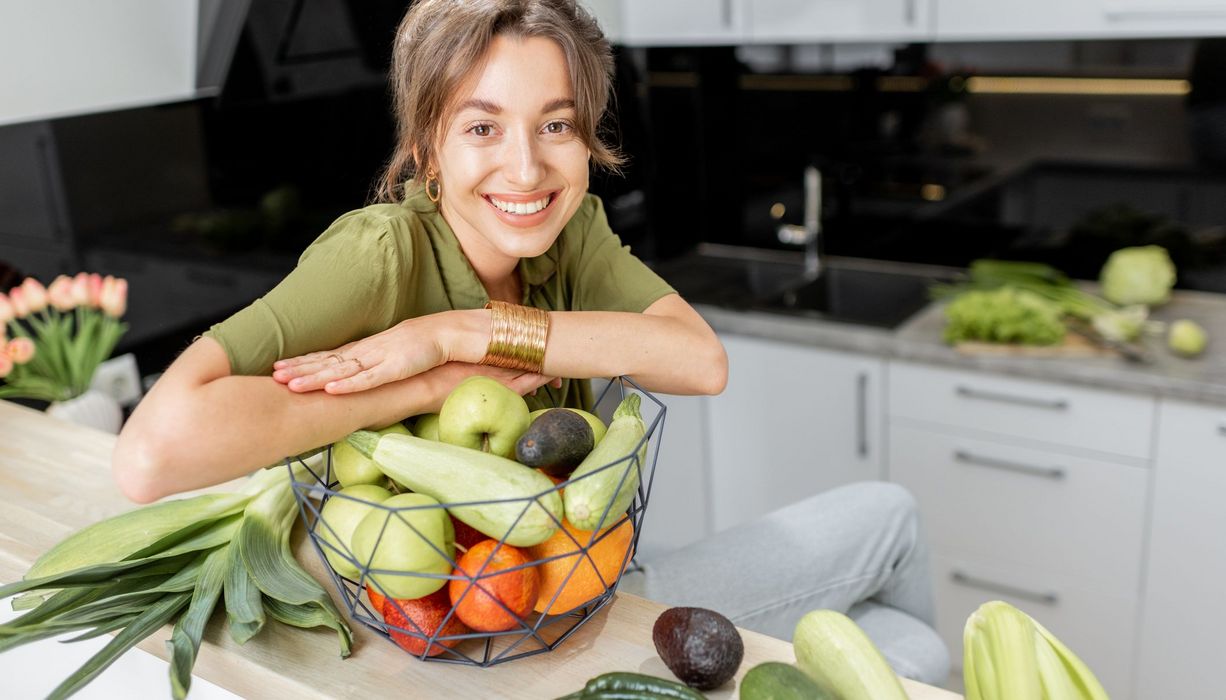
[889, 425, 1149, 596]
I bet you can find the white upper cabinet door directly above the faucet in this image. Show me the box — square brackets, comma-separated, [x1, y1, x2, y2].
[748, 0, 937, 43]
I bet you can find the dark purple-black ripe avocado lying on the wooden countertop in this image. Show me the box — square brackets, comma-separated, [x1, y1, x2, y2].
[651, 608, 745, 690]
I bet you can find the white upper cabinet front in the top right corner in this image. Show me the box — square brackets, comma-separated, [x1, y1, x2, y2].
[933, 0, 1226, 40]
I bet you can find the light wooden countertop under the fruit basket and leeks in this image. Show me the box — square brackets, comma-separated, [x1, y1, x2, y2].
[0, 401, 959, 700]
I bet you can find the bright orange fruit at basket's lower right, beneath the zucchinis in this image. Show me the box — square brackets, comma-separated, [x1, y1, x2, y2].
[528, 517, 634, 615]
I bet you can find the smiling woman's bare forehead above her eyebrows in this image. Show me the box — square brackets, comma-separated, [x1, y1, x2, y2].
[454, 36, 575, 113]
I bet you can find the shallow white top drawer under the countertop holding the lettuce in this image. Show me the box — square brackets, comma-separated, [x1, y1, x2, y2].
[889, 363, 1155, 460]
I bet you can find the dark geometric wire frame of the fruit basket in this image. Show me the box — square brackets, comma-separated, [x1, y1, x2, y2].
[286, 376, 667, 667]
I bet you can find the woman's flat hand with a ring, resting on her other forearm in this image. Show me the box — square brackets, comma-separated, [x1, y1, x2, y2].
[272, 316, 447, 394]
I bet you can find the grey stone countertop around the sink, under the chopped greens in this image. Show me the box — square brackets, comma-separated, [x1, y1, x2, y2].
[696, 291, 1226, 406]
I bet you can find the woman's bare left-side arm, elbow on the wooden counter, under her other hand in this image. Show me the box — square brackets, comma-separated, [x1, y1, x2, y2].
[112, 337, 547, 503]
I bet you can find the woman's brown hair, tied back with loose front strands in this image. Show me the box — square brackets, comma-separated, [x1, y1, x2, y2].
[375, 0, 623, 202]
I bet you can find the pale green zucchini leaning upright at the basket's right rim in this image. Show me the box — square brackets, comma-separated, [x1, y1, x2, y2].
[562, 394, 647, 530]
